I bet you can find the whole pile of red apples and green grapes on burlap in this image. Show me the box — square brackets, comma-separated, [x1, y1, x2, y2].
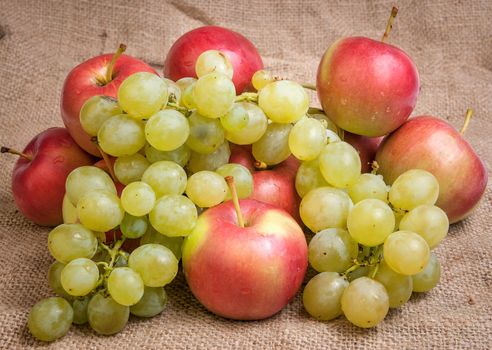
[2, 7, 487, 341]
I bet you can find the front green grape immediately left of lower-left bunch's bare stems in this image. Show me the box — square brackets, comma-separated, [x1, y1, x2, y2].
[60, 258, 99, 297]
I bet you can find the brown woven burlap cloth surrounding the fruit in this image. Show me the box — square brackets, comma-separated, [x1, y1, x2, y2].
[0, 0, 492, 349]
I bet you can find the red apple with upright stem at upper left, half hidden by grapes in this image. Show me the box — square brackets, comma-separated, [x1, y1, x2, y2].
[61, 45, 157, 157]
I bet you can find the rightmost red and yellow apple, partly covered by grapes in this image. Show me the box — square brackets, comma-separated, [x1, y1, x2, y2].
[376, 116, 488, 223]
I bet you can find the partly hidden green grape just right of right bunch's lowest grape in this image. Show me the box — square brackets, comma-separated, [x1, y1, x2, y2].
[374, 261, 413, 308]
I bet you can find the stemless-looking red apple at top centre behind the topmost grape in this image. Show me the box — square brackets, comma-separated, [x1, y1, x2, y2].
[164, 26, 263, 94]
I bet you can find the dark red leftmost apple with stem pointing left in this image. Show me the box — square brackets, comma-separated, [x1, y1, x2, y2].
[2, 128, 94, 226]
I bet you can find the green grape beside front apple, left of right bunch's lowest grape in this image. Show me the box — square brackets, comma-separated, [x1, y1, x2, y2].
[302, 272, 349, 321]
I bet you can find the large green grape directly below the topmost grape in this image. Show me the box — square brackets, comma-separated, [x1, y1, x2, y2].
[193, 72, 236, 118]
